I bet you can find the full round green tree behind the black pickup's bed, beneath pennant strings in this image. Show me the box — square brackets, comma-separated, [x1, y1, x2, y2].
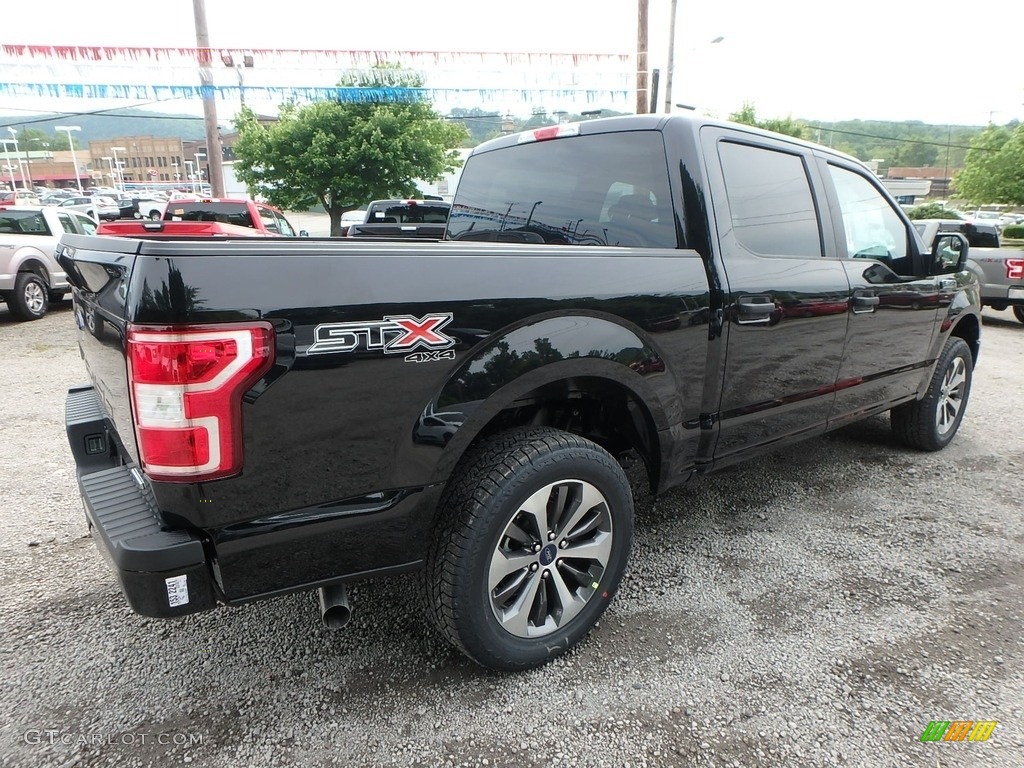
[234, 65, 466, 236]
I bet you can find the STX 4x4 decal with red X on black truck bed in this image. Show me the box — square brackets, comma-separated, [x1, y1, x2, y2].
[306, 312, 456, 362]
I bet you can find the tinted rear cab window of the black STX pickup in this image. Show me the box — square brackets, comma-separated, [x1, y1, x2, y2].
[446, 131, 678, 248]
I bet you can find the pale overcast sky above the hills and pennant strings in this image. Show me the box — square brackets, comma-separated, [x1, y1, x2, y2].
[0, 0, 1024, 125]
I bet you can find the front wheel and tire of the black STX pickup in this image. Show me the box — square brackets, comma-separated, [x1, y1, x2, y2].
[889, 336, 974, 451]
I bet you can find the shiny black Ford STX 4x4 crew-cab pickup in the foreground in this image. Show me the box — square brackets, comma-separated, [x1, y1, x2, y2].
[58, 116, 981, 670]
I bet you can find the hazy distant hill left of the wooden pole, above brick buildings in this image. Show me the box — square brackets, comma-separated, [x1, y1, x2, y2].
[0, 110, 206, 145]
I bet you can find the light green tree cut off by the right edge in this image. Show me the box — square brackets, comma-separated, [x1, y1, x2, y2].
[953, 124, 1024, 205]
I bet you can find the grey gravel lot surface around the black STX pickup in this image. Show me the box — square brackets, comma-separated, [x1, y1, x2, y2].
[0, 302, 1024, 768]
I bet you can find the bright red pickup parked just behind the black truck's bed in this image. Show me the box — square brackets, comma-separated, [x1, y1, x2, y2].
[97, 198, 308, 238]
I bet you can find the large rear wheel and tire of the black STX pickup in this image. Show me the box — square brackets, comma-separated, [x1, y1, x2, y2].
[426, 428, 633, 672]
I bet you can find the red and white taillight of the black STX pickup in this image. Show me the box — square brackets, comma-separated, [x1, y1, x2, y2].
[128, 323, 273, 482]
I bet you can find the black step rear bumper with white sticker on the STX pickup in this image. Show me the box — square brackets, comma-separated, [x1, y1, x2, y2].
[65, 387, 217, 617]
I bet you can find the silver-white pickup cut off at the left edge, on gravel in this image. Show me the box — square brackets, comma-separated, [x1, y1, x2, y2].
[0, 206, 96, 319]
